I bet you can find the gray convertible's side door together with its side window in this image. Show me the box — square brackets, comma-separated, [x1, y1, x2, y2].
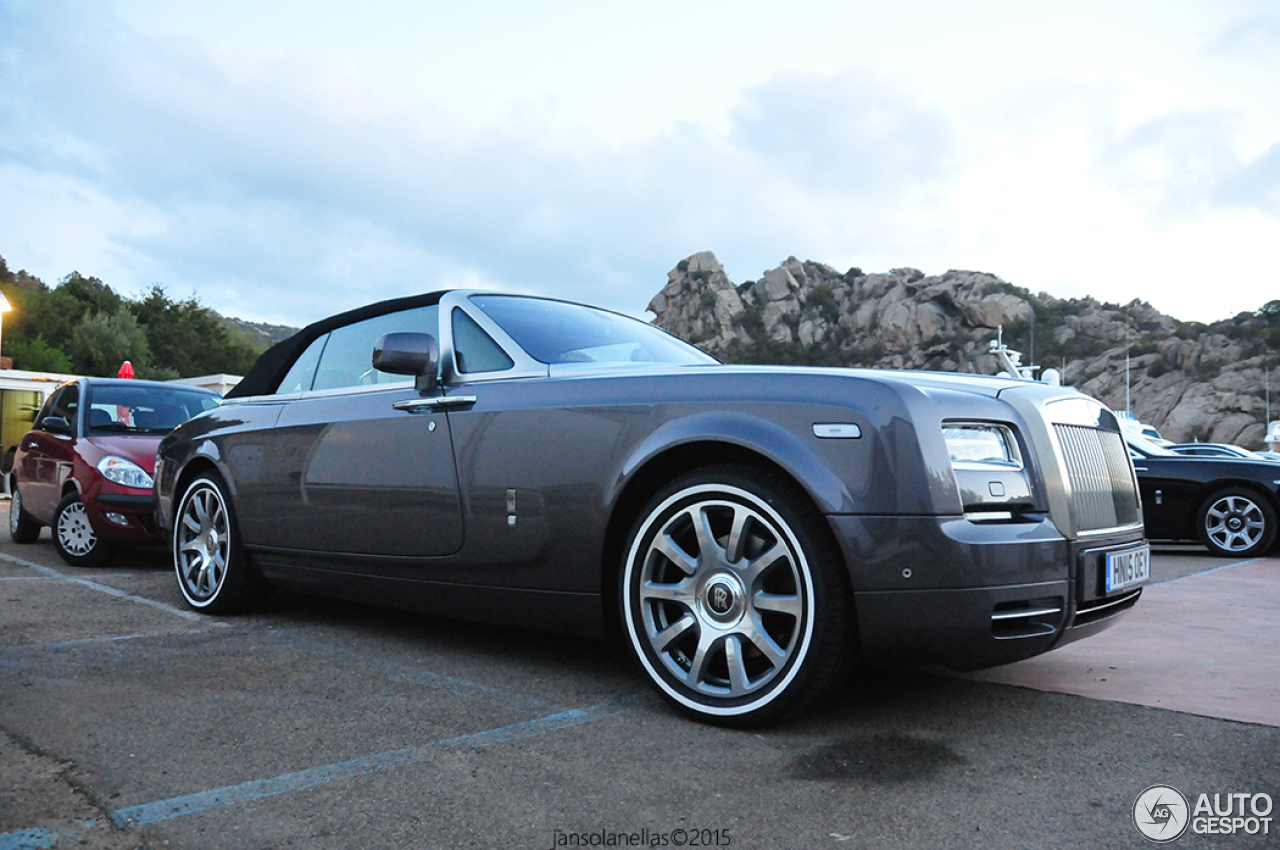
[244, 306, 463, 558]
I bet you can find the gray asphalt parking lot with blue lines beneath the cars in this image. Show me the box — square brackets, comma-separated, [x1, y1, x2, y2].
[0, 503, 1280, 850]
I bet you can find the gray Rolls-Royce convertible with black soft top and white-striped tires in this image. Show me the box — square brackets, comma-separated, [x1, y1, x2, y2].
[155, 291, 1149, 726]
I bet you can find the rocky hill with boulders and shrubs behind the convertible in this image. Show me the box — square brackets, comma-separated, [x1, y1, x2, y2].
[649, 251, 1280, 448]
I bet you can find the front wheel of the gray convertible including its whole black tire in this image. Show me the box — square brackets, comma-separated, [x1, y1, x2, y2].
[620, 465, 852, 727]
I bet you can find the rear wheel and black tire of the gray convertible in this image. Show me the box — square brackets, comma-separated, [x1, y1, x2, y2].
[173, 472, 266, 614]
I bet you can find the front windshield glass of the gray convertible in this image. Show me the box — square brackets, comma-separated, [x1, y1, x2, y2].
[471, 296, 717, 365]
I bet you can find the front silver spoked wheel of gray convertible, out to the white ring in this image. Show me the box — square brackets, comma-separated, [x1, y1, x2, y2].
[625, 485, 813, 716]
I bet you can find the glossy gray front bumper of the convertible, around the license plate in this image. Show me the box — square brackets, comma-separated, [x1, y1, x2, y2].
[828, 516, 1143, 670]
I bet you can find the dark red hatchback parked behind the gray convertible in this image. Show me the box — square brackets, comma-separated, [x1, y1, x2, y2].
[9, 378, 220, 567]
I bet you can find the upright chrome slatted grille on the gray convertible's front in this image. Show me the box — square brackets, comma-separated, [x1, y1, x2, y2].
[1053, 424, 1142, 531]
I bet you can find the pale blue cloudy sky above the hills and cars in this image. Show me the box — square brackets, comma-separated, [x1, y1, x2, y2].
[0, 0, 1280, 325]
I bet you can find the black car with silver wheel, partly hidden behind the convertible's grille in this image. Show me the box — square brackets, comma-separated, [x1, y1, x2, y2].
[1128, 435, 1280, 557]
